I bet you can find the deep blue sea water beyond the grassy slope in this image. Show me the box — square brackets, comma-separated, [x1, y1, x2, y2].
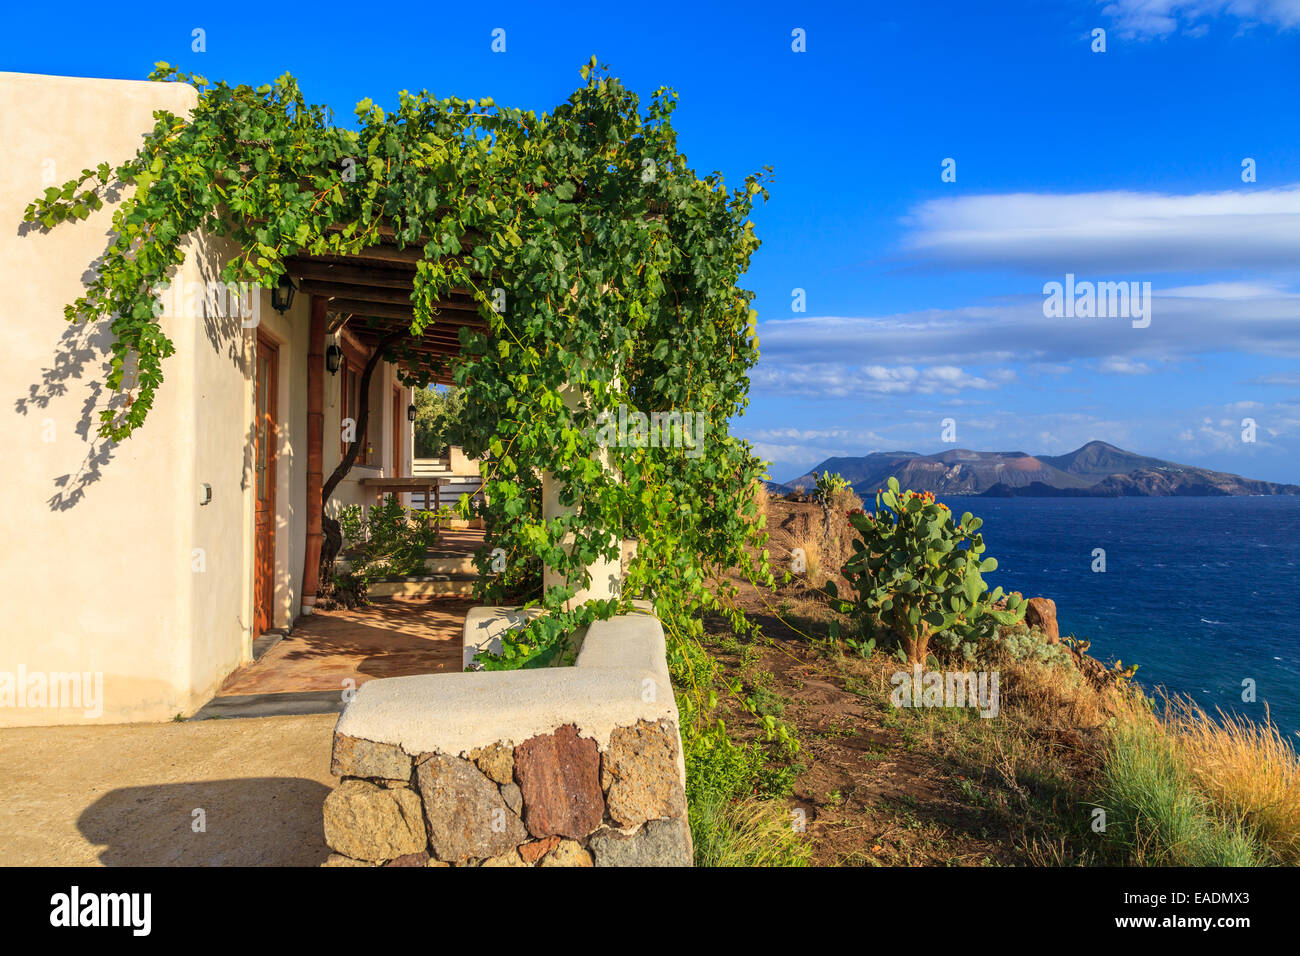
[946, 496, 1300, 743]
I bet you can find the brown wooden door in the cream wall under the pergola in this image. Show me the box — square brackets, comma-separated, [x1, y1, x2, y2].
[254, 336, 280, 636]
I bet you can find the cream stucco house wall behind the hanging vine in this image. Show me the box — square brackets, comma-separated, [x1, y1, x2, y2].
[0, 73, 413, 726]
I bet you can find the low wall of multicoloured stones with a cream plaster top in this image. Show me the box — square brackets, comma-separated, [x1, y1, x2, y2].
[325, 614, 692, 866]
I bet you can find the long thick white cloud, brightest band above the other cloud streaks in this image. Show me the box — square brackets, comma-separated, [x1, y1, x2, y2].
[904, 183, 1300, 273]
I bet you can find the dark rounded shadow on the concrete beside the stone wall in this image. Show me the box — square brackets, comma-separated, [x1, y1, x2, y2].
[77, 777, 330, 866]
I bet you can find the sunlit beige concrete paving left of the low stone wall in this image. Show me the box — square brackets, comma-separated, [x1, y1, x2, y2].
[0, 714, 337, 866]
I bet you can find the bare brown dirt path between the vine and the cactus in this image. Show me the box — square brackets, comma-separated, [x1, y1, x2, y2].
[706, 498, 1086, 866]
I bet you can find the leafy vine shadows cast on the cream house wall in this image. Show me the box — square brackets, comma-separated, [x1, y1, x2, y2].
[14, 201, 254, 511]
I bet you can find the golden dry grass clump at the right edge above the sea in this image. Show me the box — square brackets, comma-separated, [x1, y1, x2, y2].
[1165, 698, 1300, 866]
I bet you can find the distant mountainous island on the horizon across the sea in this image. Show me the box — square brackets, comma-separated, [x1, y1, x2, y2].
[768, 441, 1300, 501]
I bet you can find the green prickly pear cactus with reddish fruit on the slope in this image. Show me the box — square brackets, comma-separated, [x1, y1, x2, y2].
[827, 477, 1024, 663]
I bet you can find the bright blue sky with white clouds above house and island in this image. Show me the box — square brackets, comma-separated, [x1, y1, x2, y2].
[0, 0, 1300, 483]
